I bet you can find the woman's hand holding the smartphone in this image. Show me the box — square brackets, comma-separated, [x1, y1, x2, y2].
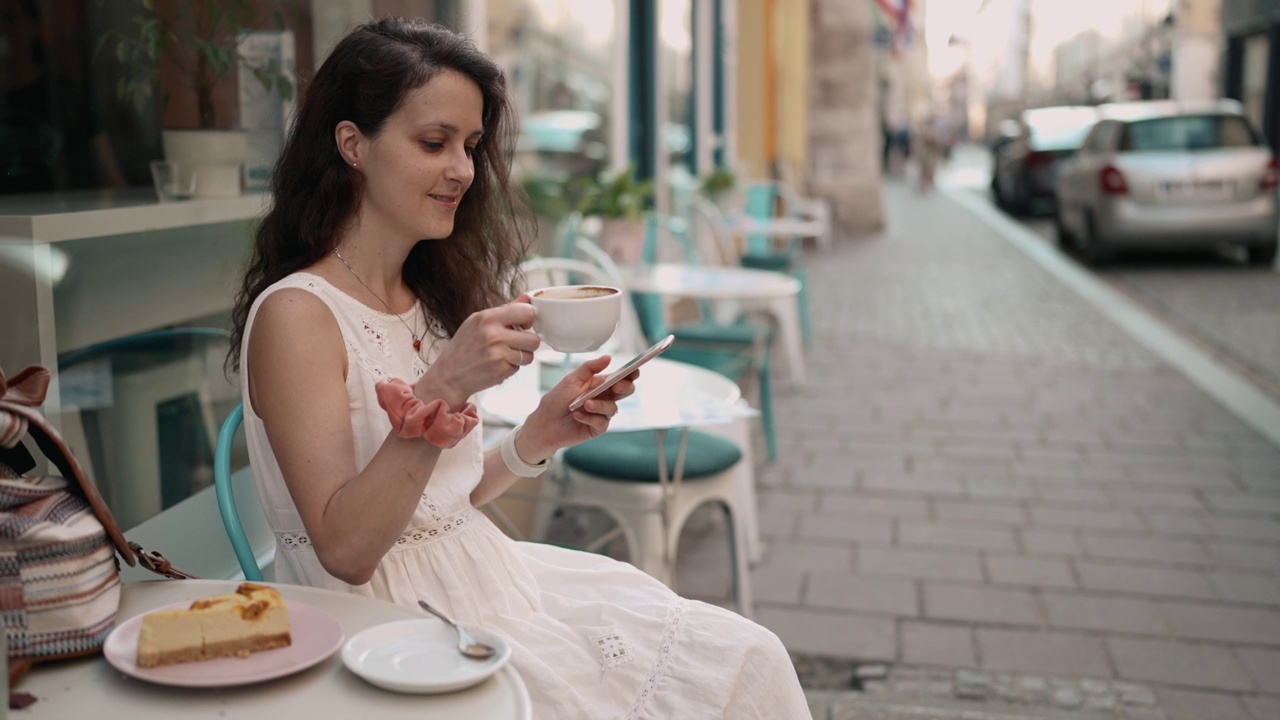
[516, 355, 640, 462]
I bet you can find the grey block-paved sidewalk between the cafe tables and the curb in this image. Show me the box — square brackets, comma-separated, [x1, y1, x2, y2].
[678, 175, 1280, 720]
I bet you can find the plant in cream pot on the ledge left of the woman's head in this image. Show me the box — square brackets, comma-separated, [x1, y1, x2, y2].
[99, 0, 294, 196]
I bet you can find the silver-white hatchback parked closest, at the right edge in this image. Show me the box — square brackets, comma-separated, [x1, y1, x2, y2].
[1055, 100, 1280, 265]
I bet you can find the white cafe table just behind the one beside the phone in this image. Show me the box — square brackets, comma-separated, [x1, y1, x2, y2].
[621, 263, 805, 384]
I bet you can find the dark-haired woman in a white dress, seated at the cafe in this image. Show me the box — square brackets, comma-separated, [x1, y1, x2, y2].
[232, 19, 808, 719]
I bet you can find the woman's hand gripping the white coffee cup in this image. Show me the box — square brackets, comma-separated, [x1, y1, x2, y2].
[415, 295, 541, 410]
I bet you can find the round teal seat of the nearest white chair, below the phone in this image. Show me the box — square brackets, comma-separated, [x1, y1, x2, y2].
[564, 430, 742, 483]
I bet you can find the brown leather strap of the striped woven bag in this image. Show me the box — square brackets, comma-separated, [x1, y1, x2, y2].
[0, 365, 195, 578]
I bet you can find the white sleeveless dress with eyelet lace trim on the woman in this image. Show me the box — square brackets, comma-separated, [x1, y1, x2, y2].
[242, 273, 809, 720]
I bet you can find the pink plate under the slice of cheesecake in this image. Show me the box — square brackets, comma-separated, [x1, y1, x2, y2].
[102, 600, 343, 688]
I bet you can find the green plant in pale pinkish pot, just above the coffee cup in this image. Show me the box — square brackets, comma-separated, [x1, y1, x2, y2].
[570, 165, 654, 263]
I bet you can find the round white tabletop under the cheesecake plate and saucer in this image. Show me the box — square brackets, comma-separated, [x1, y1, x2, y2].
[20, 580, 531, 720]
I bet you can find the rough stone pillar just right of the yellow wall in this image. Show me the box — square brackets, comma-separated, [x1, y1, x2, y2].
[808, 0, 884, 235]
